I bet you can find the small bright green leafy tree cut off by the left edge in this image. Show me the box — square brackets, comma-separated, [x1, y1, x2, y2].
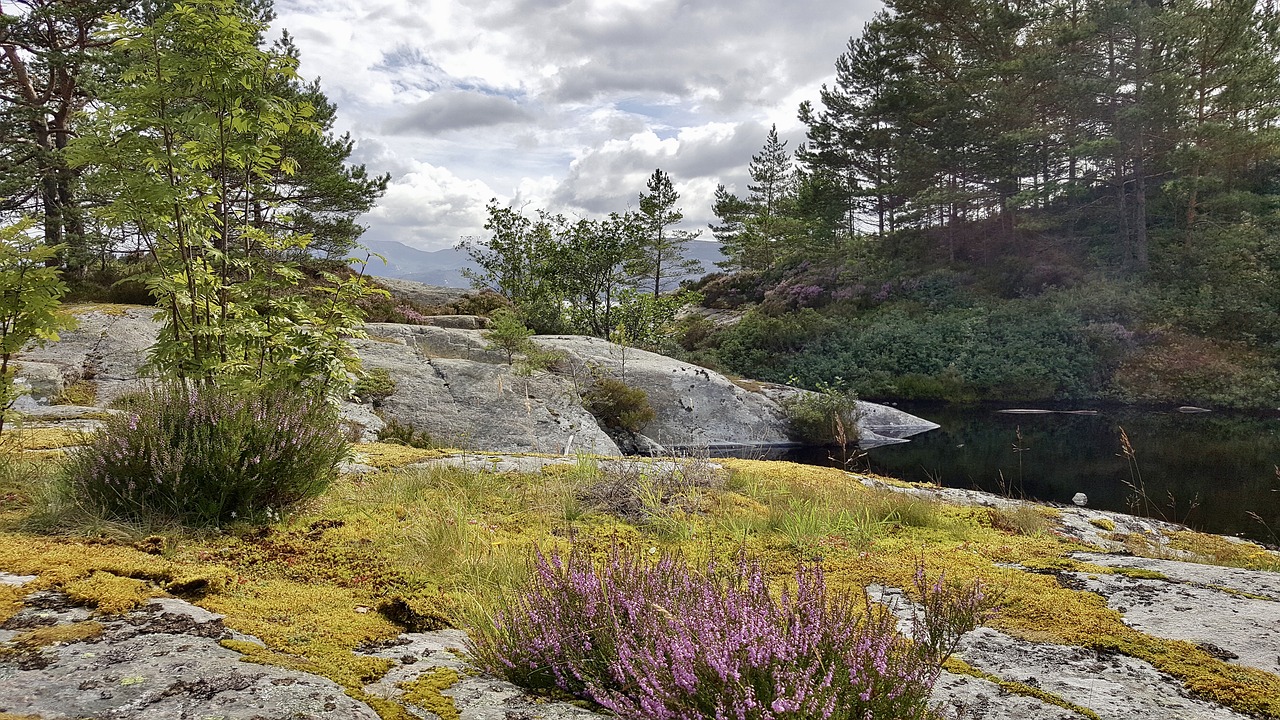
[0, 218, 73, 432]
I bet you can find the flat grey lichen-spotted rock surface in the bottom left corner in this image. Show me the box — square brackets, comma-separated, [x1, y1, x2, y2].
[0, 593, 378, 720]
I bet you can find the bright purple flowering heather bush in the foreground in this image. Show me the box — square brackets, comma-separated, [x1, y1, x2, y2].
[471, 548, 983, 720]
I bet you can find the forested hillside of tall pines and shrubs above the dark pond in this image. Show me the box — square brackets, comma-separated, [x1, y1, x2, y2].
[681, 0, 1280, 407]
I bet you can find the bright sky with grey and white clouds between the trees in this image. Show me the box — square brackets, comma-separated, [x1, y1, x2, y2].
[275, 0, 879, 250]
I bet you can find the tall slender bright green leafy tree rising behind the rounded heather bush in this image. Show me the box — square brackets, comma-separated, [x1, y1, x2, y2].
[69, 0, 370, 396]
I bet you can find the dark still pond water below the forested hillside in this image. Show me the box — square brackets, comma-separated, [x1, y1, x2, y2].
[788, 404, 1280, 543]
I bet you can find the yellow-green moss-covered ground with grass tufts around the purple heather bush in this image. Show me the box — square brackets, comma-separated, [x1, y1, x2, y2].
[0, 443, 1280, 719]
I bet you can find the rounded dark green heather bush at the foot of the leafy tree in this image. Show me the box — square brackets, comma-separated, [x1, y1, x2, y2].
[67, 384, 348, 525]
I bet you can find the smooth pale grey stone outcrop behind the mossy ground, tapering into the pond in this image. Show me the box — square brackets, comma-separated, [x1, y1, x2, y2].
[22, 307, 937, 455]
